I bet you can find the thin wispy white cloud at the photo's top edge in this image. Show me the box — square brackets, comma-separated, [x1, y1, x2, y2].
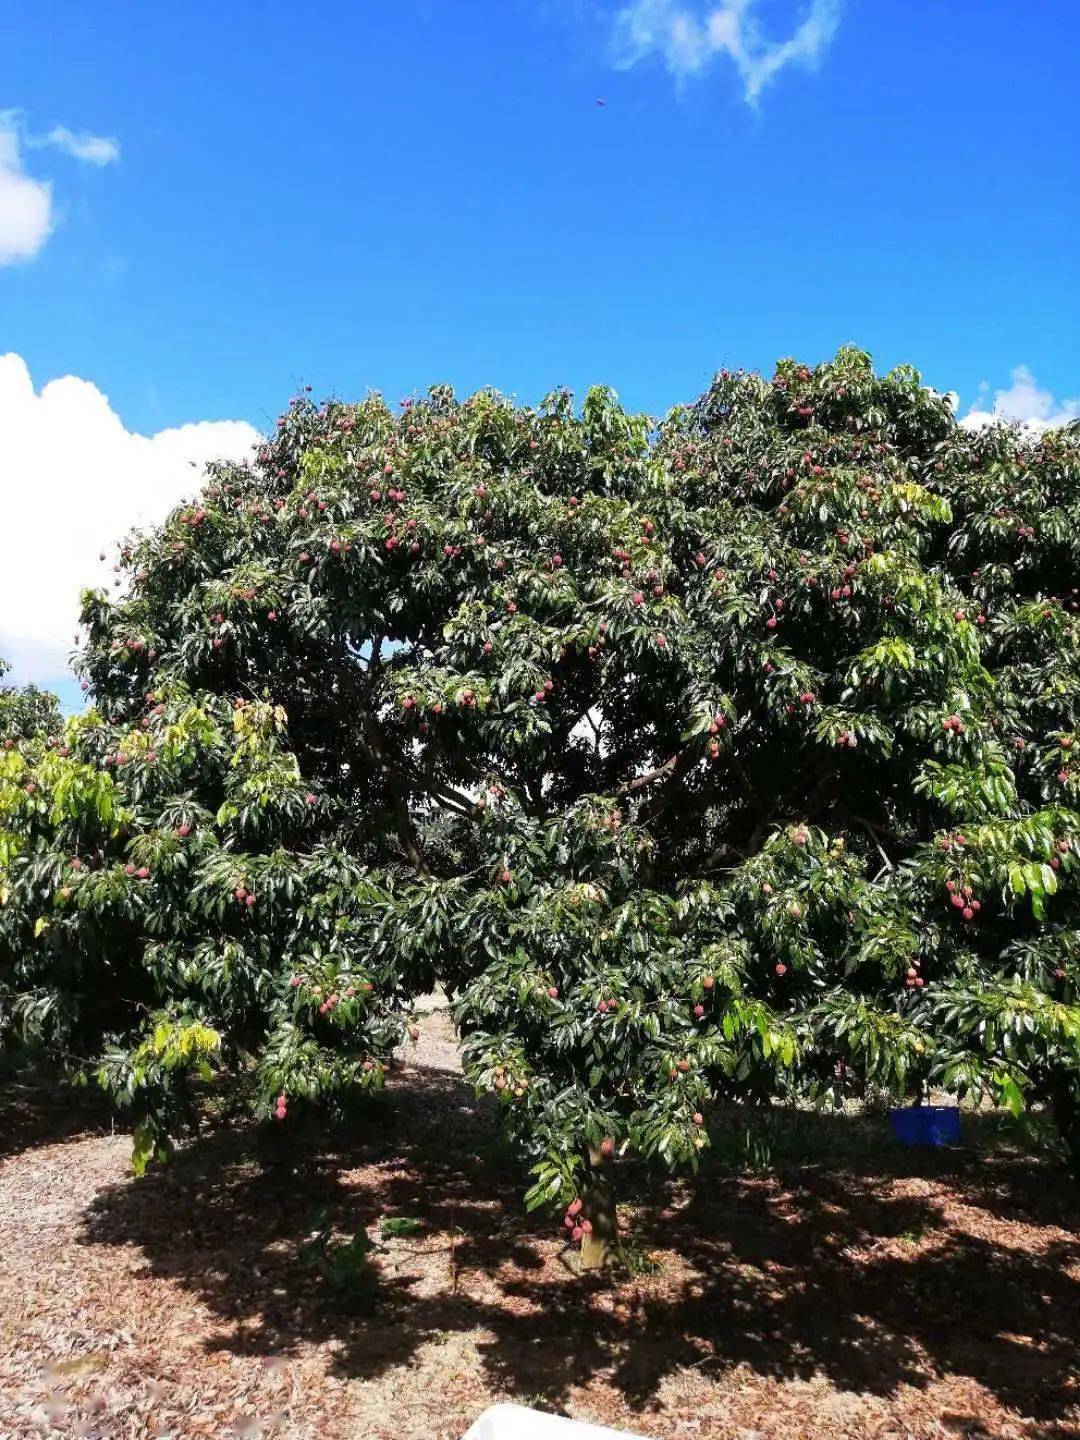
[612, 0, 842, 105]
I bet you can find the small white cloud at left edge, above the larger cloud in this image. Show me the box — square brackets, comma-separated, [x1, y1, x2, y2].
[0, 109, 120, 265]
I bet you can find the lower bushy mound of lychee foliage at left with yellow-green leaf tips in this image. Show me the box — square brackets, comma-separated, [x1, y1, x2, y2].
[0, 681, 423, 1171]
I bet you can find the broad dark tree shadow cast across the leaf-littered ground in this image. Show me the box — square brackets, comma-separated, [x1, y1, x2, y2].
[81, 1068, 1080, 1434]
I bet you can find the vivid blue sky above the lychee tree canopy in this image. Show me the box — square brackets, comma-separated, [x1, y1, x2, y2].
[0, 0, 1080, 696]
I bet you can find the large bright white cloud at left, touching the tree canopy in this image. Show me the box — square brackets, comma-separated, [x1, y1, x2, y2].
[0, 354, 258, 683]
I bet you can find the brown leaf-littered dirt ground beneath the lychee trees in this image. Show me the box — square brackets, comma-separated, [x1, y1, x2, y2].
[0, 1012, 1080, 1440]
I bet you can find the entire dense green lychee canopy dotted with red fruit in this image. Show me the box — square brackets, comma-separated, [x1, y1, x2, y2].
[0, 342, 1080, 1223]
